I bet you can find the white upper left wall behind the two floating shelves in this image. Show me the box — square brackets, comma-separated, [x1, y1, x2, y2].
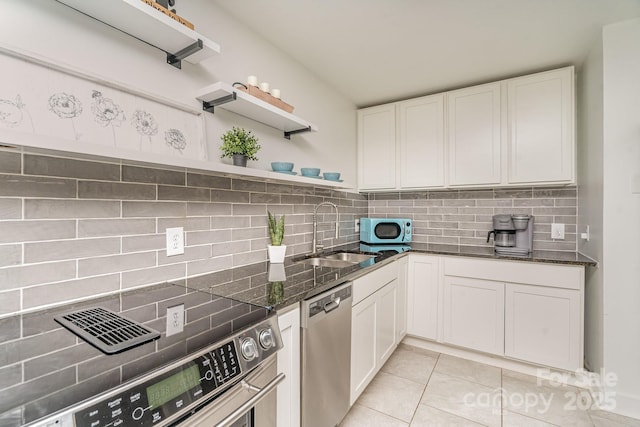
[0, 0, 356, 187]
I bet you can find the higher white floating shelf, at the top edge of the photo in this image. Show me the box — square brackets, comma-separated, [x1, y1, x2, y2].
[57, 0, 220, 68]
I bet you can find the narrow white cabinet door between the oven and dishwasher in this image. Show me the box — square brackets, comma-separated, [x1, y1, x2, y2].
[276, 308, 300, 427]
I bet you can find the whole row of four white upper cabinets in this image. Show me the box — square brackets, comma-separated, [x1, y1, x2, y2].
[358, 67, 576, 191]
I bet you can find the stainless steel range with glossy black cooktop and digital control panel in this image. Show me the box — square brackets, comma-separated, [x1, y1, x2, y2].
[0, 284, 284, 427]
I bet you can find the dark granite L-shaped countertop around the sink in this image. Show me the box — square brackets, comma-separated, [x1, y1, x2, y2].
[182, 243, 597, 310]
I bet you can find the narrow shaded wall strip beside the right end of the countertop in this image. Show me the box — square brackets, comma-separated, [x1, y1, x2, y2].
[577, 36, 604, 372]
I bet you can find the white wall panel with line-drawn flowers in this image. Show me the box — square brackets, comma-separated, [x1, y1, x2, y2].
[0, 50, 207, 163]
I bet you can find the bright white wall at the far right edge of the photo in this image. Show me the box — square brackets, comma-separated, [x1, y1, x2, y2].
[602, 19, 640, 418]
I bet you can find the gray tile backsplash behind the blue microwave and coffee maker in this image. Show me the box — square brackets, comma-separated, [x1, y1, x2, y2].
[369, 187, 577, 251]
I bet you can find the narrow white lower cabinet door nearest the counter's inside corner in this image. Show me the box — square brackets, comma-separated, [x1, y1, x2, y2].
[407, 255, 440, 340]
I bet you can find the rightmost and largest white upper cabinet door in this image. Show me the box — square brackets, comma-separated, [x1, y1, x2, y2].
[507, 67, 576, 183]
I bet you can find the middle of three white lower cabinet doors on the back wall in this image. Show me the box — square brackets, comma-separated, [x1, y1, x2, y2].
[443, 276, 504, 355]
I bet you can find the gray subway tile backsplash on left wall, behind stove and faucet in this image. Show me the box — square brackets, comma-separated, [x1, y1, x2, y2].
[0, 149, 368, 320]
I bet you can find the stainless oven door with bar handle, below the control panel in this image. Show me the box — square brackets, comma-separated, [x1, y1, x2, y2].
[174, 357, 284, 427]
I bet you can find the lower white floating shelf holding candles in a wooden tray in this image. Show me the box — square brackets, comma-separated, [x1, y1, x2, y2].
[196, 82, 318, 139]
